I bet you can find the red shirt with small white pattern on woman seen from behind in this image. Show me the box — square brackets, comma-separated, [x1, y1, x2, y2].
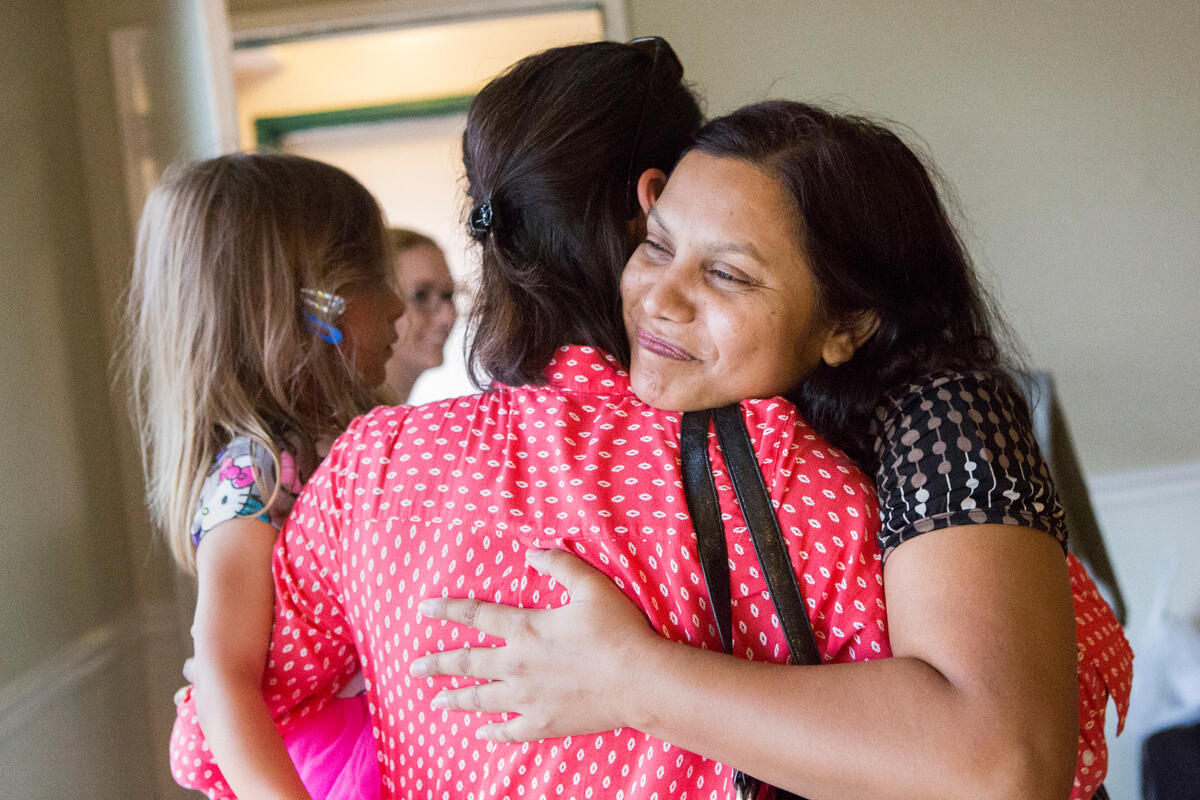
[172, 348, 890, 800]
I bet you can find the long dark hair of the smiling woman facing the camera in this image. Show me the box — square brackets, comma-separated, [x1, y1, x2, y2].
[695, 101, 1027, 469]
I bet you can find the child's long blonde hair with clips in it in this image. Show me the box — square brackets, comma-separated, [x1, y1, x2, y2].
[125, 154, 395, 572]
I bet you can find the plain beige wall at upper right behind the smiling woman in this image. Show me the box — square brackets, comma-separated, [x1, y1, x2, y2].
[629, 0, 1200, 474]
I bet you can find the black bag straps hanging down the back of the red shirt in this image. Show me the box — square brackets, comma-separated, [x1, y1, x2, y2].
[679, 404, 821, 800]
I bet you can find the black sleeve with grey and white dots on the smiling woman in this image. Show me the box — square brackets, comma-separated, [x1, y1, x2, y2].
[872, 372, 1067, 558]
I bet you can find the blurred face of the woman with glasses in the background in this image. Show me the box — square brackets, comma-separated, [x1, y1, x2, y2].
[389, 245, 457, 372]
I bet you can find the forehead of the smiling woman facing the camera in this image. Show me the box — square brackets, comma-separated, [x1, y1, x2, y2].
[655, 151, 798, 251]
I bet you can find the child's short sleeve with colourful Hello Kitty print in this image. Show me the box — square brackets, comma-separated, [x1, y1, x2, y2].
[192, 437, 300, 547]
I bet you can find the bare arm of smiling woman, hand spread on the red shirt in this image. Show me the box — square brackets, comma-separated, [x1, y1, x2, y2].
[414, 524, 1078, 800]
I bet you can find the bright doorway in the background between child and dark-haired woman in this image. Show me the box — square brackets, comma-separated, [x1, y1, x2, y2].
[232, 2, 624, 403]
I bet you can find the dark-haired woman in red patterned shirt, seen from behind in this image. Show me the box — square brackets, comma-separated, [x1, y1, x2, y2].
[211, 40, 889, 798]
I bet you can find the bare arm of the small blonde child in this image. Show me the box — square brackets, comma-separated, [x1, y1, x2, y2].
[192, 518, 310, 800]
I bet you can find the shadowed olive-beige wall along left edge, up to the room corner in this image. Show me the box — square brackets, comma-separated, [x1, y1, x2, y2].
[0, 0, 164, 798]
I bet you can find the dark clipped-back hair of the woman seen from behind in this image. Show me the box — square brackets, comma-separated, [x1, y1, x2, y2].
[462, 42, 703, 386]
